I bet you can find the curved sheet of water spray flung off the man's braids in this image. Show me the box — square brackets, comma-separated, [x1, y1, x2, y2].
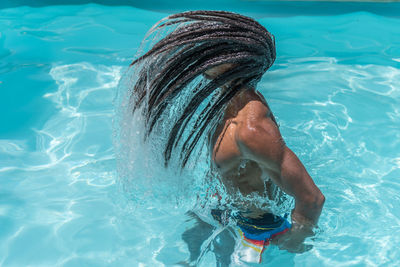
[114, 11, 290, 222]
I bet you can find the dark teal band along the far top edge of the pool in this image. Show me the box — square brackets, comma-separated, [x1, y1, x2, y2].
[0, 0, 400, 18]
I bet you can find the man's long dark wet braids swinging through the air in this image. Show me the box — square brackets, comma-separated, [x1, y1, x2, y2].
[131, 11, 276, 168]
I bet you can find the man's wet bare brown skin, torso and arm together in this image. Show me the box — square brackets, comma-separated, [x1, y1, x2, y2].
[206, 64, 325, 252]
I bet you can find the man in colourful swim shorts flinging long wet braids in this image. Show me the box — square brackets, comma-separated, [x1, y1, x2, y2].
[131, 11, 325, 261]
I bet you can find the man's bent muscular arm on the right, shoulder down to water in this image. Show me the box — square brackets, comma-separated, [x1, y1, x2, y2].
[237, 114, 325, 251]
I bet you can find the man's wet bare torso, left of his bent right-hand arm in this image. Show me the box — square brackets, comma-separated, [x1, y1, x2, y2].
[212, 90, 278, 214]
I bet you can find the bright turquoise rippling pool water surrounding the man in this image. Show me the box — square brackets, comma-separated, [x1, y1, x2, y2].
[0, 2, 400, 266]
